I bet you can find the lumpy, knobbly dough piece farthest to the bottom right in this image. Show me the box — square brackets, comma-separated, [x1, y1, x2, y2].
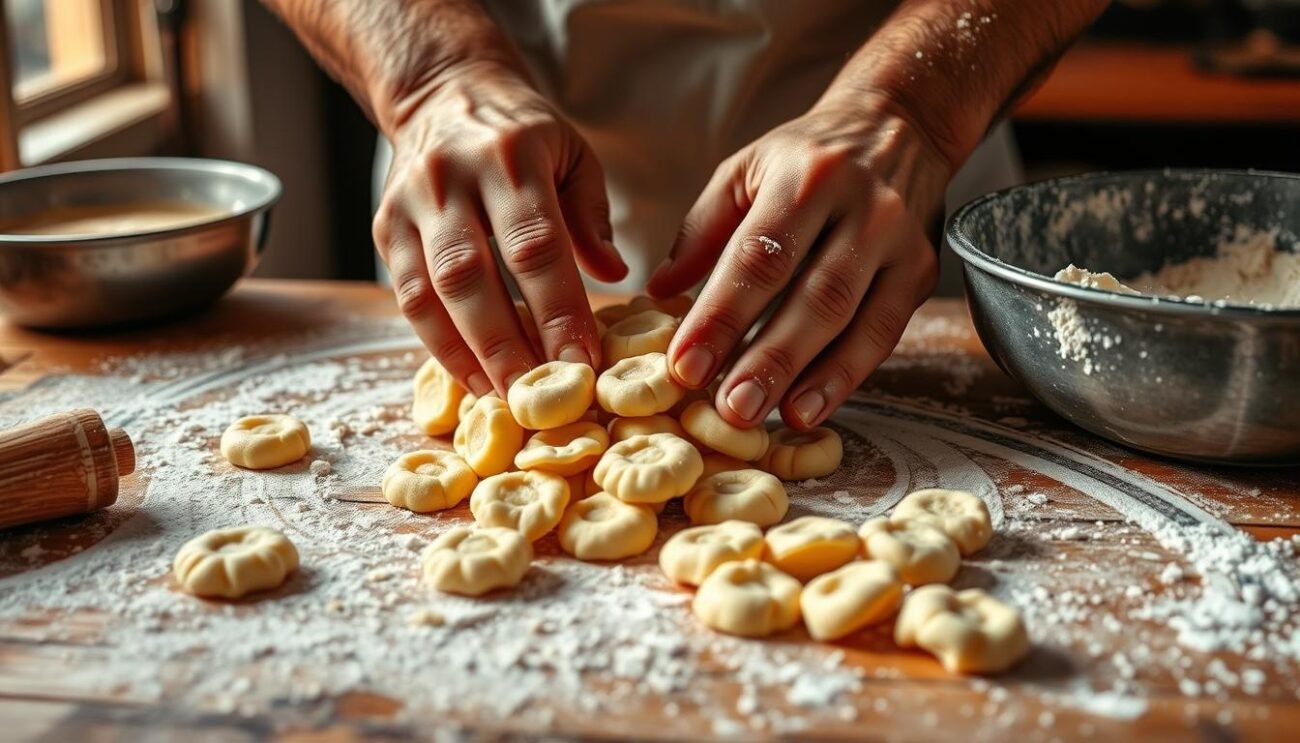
[894, 586, 1030, 673]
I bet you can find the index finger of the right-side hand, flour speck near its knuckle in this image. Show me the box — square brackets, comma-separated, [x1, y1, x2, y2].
[668, 184, 828, 392]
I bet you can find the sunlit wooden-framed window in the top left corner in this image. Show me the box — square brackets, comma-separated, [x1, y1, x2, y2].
[0, 0, 176, 170]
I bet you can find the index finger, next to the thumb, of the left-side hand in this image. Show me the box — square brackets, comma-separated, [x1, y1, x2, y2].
[482, 154, 601, 366]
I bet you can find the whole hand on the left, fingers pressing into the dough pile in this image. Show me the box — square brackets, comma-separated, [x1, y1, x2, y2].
[373, 64, 628, 396]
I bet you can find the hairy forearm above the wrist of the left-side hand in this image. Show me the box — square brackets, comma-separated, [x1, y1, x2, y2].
[263, 0, 523, 136]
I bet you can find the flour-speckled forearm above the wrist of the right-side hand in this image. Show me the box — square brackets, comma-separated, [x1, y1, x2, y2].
[823, 0, 1106, 171]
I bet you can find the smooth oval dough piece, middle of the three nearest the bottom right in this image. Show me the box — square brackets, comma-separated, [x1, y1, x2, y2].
[800, 560, 902, 642]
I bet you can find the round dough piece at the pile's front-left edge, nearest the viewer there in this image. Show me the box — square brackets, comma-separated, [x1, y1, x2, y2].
[420, 526, 533, 596]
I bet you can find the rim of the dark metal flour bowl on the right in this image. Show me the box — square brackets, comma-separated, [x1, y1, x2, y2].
[944, 168, 1300, 320]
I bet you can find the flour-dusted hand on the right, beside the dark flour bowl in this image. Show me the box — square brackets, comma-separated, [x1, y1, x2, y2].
[649, 94, 952, 429]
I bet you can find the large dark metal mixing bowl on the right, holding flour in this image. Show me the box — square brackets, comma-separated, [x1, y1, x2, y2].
[946, 170, 1300, 464]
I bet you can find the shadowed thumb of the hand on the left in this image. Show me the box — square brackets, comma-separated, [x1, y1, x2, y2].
[559, 147, 628, 283]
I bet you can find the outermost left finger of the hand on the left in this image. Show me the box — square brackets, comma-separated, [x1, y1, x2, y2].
[374, 210, 491, 395]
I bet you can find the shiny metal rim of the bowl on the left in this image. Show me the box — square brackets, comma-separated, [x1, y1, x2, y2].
[0, 157, 285, 248]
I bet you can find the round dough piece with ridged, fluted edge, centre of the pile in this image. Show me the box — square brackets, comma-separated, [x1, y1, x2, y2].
[593, 434, 705, 504]
